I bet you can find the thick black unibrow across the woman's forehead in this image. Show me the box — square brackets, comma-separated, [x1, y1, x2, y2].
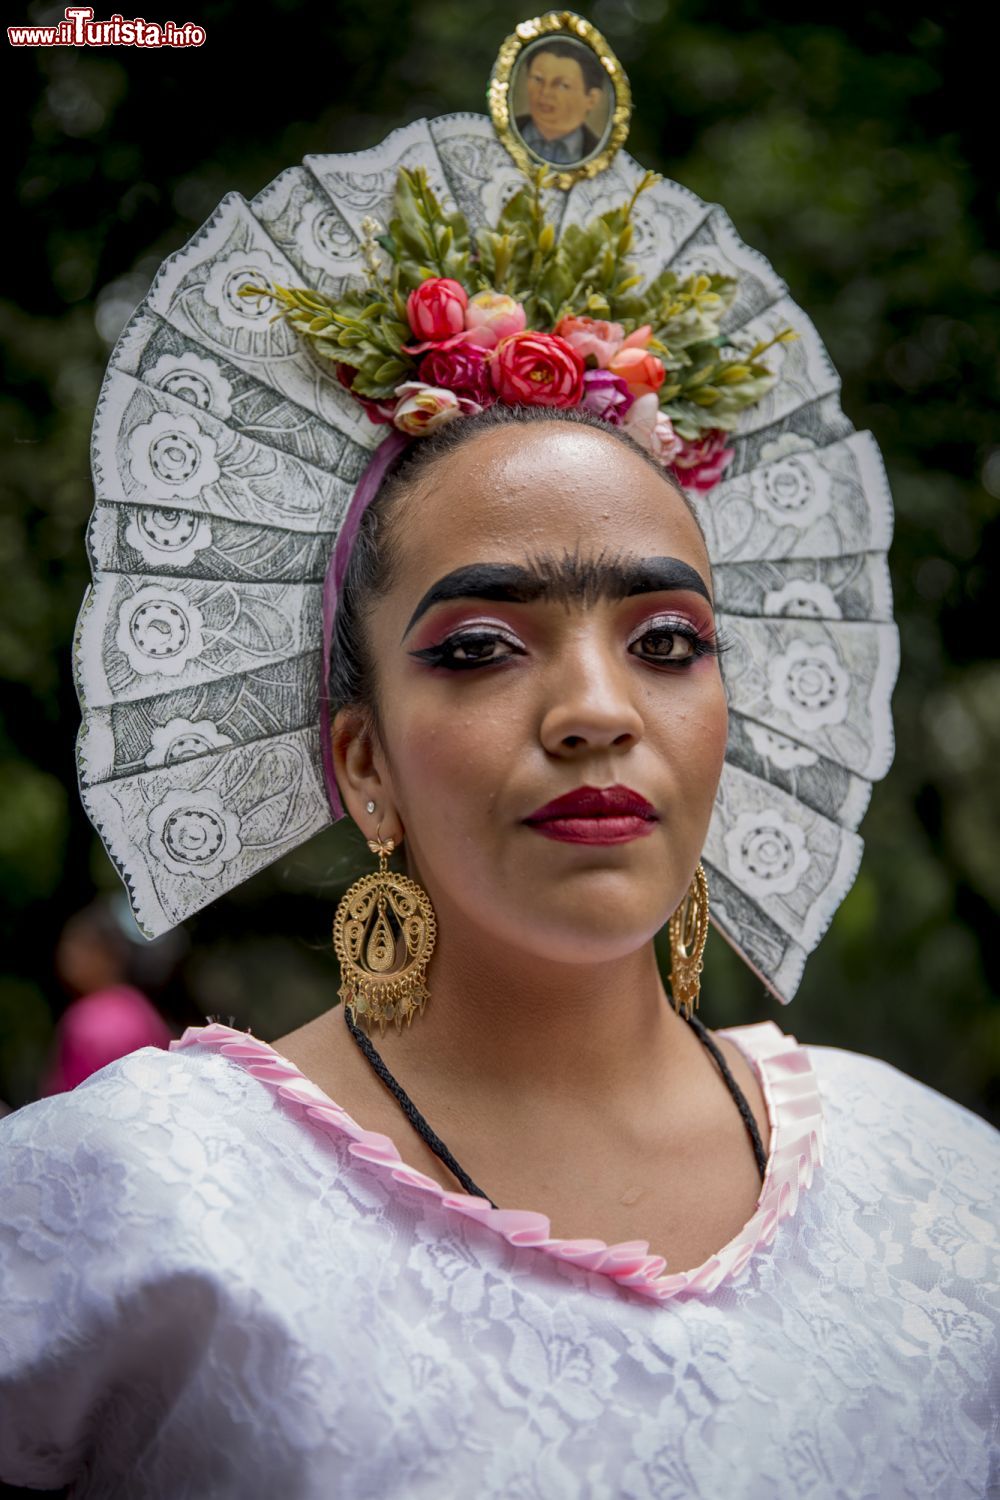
[403, 554, 712, 641]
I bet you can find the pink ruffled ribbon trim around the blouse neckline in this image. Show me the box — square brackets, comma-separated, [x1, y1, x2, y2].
[169, 1022, 823, 1302]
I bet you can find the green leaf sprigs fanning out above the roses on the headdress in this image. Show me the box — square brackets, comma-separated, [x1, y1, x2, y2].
[241, 167, 798, 441]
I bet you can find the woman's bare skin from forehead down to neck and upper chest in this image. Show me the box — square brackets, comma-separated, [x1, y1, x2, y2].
[276, 408, 768, 1271]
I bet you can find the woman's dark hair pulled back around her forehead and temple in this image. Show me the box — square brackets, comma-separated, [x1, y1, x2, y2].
[330, 402, 702, 729]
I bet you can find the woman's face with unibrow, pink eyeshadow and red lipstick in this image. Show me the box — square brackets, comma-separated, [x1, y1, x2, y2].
[342, 423, 727, 963]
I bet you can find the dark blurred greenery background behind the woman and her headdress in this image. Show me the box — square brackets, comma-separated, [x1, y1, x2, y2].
[0, 0, 1000, 1121]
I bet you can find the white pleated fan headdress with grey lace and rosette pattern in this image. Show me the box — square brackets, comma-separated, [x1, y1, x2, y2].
[75, 61, 898, 1001]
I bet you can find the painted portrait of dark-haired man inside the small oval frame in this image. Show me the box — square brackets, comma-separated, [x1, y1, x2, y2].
[511, 38, 612, 167]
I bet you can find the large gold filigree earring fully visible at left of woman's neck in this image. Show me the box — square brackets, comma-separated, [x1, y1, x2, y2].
[333, 824, 438, 1037]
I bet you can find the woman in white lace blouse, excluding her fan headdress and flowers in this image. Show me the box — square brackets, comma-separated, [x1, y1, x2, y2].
[0, 408, 1000, 1500]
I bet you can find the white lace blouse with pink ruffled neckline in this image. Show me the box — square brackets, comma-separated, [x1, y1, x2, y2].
[0, 1022, 1000, 1500]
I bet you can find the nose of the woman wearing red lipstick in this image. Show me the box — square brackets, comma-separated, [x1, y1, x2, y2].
[541, 648, 643, 755]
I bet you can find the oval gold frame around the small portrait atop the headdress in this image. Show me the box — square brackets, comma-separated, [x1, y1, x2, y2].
[487, 11, 631, 189]
